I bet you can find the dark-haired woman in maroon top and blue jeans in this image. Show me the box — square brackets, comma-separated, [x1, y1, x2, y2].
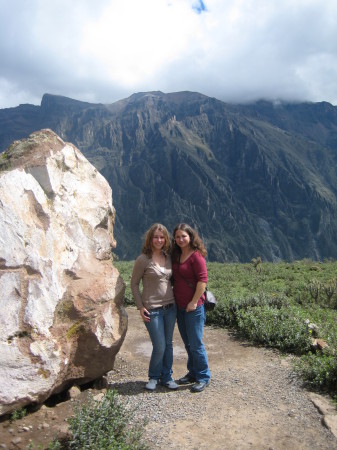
[172, 223, 211, 392]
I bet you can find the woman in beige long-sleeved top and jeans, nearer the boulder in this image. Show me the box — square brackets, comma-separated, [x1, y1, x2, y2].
[131, 223, 178, 391]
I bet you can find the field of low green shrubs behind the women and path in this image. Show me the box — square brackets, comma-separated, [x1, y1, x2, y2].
[114, 260, 337, 399]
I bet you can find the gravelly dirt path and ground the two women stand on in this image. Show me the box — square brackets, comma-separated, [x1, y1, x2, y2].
[0, 308, 337, 450]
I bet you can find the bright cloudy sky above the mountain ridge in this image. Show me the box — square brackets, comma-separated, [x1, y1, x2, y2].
[0, 0, 337, 108]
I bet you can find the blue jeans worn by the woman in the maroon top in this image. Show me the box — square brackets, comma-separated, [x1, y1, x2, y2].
[177, 305, 211, 382]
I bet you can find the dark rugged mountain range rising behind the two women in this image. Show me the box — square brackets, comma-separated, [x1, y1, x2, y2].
[0, 92, 337, 262]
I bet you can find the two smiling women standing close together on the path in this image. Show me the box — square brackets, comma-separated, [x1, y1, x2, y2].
[131, 224, 211, 392]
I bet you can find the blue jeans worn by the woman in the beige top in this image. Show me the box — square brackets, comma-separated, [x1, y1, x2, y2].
[145, 304, 177, 383]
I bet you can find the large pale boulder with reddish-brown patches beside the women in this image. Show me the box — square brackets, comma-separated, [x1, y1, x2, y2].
[0, 130, 127, 415]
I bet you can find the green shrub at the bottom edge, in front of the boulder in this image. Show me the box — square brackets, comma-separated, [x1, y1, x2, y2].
[69, 390, 147, 450]
